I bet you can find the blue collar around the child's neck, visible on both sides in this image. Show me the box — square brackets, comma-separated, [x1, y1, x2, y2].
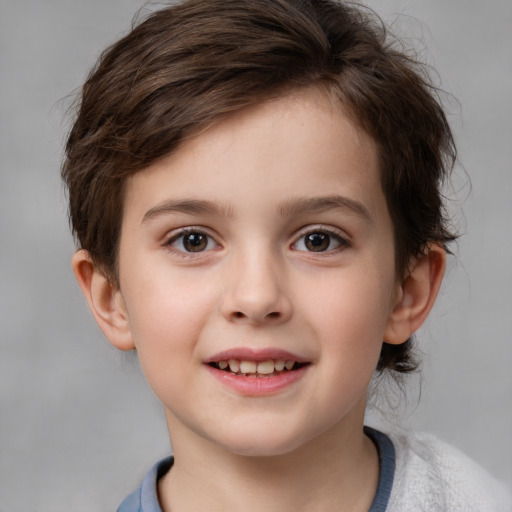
[117, 427, 395, 512]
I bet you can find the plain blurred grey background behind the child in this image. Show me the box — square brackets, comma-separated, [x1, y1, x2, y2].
[0, 0, 512, 512]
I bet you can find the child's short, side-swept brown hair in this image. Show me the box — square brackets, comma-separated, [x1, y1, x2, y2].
[62, 0, 455, 372]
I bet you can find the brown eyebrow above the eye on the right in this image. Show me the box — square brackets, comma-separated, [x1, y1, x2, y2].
[278, 195, 372, 223]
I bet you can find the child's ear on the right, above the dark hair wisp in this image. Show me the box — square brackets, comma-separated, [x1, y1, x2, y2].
[384, 245, 446, 345]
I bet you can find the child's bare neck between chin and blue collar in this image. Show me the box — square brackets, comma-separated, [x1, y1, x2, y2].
[159, 410, 379, 512]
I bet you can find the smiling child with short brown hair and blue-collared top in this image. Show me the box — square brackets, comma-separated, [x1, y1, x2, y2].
[63, 0, 512, 512]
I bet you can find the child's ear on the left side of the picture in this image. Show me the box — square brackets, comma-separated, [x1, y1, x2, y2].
[71, 250, 135, 350]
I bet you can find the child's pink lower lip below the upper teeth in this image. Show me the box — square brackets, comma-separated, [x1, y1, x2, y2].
[206, 365, 310, 396]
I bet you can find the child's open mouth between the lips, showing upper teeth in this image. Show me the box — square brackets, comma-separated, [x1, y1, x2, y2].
[208, 359, 309, 378]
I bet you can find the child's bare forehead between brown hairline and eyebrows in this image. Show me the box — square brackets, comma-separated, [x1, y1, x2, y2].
[125, 91, 383, 224]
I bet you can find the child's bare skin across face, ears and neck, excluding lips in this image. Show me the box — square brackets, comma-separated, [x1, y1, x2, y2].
[73, 91, 445, 512]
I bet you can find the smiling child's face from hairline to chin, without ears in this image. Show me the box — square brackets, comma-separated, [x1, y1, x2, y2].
[119, 93, 400, 455]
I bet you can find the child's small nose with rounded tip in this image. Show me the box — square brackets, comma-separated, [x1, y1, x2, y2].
[222, 247, 292, 325]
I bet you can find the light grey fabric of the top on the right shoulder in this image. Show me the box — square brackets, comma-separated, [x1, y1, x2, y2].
[389, 433, 512, 512]
